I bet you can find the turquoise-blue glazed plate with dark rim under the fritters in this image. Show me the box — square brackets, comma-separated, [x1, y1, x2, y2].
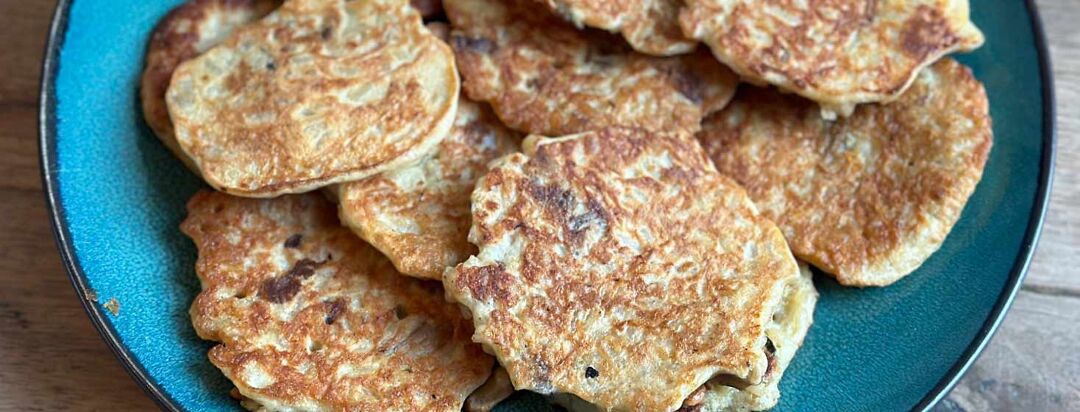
[41, 0, 1054, 411]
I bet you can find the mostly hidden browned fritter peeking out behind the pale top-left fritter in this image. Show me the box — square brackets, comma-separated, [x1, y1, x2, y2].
[139, 0, 281, 172]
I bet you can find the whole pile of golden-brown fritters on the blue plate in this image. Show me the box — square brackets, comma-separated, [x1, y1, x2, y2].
[141, 0, 991, 411]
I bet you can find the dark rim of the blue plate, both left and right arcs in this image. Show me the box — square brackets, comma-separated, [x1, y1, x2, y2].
[38, 0, 1057, 412]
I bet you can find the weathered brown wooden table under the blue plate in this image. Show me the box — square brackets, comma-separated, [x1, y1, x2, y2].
[0, 0, 1080, 411]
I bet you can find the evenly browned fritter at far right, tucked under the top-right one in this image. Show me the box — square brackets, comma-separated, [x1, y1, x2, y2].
[699, 58, 993, 285]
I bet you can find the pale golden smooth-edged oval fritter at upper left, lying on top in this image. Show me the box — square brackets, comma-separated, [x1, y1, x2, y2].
[165, 0, 458, 197]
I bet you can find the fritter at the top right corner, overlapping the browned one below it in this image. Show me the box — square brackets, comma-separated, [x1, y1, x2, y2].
[680, 0, 983, 118]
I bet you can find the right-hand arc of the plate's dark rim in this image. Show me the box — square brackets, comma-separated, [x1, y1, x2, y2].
[912, 0, 1057, 412]
